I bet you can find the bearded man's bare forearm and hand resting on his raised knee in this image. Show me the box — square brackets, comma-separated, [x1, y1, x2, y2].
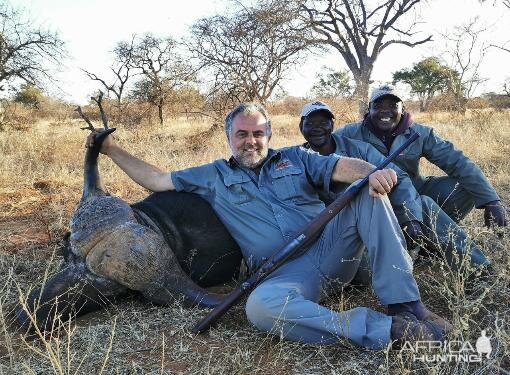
[331, 157, 397, 197]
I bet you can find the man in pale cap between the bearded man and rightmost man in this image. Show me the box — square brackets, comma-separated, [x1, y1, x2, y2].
[300, 98, 498, 272]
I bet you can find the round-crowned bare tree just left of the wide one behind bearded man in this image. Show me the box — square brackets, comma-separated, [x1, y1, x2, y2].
[123, 34, 195, 124]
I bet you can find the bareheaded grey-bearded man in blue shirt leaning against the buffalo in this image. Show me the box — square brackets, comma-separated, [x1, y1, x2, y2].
[88, 103, 451, 349]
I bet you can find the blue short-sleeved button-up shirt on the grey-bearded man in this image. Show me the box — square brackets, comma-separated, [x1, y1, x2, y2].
[171, 147, 340, 269]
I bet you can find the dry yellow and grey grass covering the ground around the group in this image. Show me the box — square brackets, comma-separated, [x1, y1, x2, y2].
[0, 112, 510, 374]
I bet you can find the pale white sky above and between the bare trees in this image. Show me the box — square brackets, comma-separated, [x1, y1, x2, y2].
[6, 0, 510, 104]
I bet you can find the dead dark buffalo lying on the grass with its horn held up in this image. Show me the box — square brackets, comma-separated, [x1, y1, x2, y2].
[16, 99, 242, 331]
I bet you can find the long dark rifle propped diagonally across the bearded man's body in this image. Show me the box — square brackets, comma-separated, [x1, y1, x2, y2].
[192, 133, 419, 333]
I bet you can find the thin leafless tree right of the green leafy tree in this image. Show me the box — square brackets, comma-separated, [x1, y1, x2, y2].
[443, 17, 489, 112]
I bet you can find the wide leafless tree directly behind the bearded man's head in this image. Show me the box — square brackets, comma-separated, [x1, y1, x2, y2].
[189, 0, 306, 114]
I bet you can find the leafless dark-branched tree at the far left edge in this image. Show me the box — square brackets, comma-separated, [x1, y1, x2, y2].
[0, 2, 65, 90]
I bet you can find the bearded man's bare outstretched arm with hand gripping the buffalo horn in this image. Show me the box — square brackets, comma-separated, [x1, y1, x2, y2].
[86, 133, 175, 191]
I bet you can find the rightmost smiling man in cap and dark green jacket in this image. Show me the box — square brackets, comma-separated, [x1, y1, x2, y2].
[335, 85, 507, 265]
